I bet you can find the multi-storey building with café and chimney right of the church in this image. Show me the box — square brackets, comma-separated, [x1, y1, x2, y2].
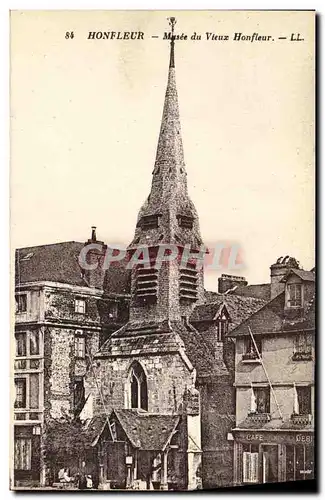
[229, 257, 315, 484]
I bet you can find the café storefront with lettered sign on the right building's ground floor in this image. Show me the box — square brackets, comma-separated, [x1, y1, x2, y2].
[233, 430, 315, 485]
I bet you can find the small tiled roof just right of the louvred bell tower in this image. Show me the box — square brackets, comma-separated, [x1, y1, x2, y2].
[190, 292, 266, 331]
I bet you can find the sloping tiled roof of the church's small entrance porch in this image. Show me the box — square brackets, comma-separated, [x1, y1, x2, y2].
[111, 410, 180, 451]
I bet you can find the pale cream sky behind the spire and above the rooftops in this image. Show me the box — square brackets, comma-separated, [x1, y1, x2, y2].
[11, 11, 315, 290]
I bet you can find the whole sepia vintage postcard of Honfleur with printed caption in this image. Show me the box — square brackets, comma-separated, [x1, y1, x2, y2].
[10, 10, 316, 492]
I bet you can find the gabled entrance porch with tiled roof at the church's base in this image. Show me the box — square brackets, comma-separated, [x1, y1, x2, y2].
[90, 410, 187, 490]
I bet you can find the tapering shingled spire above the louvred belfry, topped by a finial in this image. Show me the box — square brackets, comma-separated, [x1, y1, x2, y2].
[130, 18, 202, 252]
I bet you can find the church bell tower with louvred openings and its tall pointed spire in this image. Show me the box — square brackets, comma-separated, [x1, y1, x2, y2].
[128, 17, 204, 322]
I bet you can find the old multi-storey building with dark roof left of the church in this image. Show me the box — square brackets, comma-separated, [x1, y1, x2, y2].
[13, 236, 129, 486]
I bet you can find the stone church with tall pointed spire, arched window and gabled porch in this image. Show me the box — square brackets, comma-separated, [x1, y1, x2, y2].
[76, 24, 265, 489]
